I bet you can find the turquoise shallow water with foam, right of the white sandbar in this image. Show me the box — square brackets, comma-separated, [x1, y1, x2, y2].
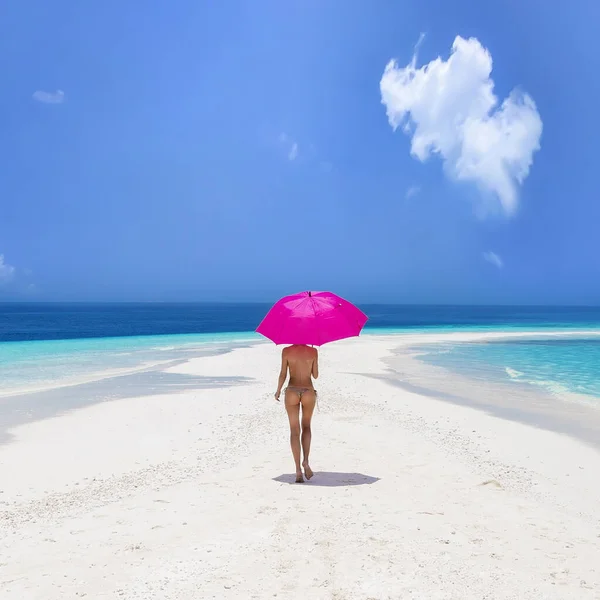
[419, 335, 600, 399]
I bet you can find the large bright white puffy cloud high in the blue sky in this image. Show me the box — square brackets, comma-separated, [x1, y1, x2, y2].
[380, 36, 542, 216]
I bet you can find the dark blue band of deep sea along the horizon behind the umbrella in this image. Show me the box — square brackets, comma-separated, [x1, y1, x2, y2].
[0, 302, 600, 343]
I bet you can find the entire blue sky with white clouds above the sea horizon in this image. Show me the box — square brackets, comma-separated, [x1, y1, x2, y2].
[0, 0, 600, 304]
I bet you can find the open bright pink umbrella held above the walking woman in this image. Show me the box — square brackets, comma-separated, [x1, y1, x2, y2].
[256, 292, 367, 346]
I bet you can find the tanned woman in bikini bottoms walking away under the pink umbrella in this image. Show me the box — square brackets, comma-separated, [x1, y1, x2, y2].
[275, 345, 319, 483]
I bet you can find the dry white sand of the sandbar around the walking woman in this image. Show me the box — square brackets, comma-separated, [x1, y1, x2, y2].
[0, 336, 600, 600]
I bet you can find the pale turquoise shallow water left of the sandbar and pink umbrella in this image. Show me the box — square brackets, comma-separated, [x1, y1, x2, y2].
[0, 333, 262, 395]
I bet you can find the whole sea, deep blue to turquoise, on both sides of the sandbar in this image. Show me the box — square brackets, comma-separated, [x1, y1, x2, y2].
[0, 304, 600, 397]
